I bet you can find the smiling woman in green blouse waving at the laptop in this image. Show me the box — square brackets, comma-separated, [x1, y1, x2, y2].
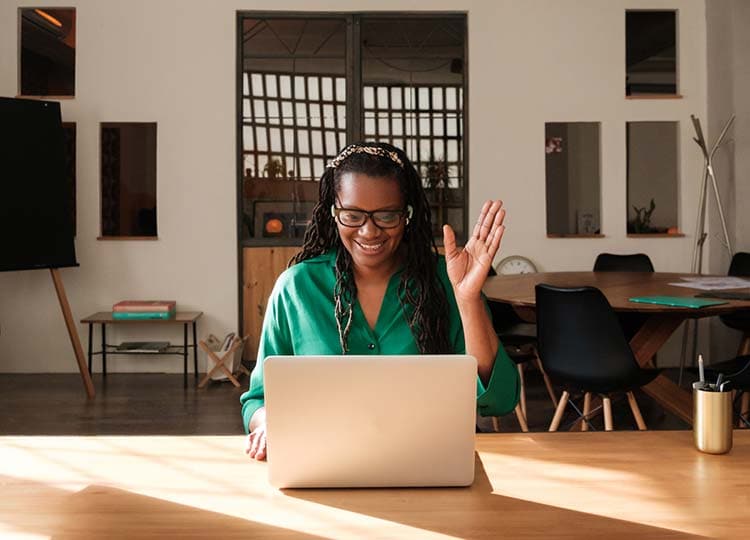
[240, 143, 519, 460]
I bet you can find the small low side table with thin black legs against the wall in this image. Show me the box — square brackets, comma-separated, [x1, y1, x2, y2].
[81, 311, 203, 388]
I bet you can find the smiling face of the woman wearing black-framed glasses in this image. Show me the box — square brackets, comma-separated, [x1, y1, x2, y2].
[334, 172, 406, 269]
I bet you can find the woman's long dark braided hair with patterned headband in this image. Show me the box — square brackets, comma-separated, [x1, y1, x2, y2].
[289, 142, 454, 354]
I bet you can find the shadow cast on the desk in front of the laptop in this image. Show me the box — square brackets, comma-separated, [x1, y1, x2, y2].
[283, 456, 702, 539]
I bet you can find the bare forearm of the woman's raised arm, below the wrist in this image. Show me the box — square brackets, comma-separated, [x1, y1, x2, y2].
[456, 297, 499, 384]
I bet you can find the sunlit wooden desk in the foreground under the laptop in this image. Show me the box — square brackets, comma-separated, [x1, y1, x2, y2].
[0, 430, 750, 540]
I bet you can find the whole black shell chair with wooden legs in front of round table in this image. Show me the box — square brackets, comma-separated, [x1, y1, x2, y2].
[536, 284, 659, 431]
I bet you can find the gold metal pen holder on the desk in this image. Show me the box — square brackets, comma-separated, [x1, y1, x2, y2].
[693, 382, 732, 454]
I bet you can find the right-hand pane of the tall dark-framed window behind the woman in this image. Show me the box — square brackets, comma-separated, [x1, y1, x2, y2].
[361, 17, 466, 238]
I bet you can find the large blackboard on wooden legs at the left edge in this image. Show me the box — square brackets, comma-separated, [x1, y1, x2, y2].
[0, 98, 78, 271]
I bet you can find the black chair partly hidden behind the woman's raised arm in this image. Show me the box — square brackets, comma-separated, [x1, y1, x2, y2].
[488, 267, 557, 432]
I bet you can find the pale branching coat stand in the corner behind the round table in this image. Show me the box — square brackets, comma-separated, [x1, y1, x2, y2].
[677, 114, 734, 386]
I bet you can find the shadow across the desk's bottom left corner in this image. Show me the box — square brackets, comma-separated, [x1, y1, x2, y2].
[0, 475, 321, 539]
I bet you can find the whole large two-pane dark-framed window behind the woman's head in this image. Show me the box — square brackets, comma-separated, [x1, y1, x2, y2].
[239, 14, 466, 243]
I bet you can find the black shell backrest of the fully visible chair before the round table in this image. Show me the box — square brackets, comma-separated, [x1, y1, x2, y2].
[536, 284, 640, 388]
